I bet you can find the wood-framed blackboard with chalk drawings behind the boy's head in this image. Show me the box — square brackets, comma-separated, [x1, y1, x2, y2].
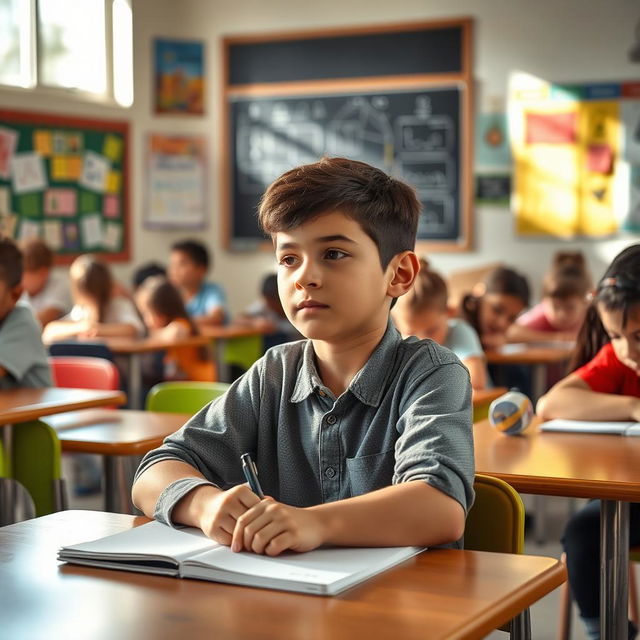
[221, 18, 473, 252]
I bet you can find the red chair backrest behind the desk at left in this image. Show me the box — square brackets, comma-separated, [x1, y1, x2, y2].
[49, 356, 120, 391]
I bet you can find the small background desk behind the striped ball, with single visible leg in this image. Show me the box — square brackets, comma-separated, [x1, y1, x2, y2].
[485, 342, 574, 402]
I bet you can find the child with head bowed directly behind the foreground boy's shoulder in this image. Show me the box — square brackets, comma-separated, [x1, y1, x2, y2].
[391, 259, 487, 389]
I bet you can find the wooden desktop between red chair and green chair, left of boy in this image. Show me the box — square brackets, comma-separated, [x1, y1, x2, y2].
[47, 409, 191, 456]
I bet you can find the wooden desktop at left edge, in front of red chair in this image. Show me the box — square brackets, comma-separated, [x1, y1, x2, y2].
[0, 387, 127, 425]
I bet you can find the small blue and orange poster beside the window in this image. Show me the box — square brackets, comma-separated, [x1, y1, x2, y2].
[154, 39, 205, 115]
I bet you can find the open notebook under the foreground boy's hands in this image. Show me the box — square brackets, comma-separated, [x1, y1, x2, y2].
[58, 521, 422, 596]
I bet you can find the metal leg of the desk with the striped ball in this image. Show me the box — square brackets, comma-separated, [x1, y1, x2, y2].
[600, 500, 629, 640]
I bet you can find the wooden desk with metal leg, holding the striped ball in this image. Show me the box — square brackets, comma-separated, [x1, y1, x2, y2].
[474, 419, 640, 639]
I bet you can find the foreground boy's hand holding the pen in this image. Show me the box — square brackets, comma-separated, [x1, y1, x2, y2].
[198, 484, 260, 546]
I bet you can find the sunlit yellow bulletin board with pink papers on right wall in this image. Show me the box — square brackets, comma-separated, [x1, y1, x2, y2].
[510, 76, 640, 238]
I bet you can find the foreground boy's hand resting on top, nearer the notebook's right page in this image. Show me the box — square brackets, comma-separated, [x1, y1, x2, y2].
[231, 498, 324, 556]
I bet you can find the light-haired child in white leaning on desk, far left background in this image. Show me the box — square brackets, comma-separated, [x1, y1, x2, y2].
[43, 254, 144, 342]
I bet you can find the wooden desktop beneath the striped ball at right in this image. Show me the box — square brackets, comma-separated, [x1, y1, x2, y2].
[473, 418, 640, 502]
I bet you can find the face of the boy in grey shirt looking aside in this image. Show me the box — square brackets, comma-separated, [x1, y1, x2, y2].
[274, 211, 393, 343]
